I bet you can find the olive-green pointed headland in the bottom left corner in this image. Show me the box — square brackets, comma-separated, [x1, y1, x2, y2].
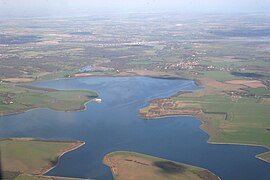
[0, 139, 83, 179]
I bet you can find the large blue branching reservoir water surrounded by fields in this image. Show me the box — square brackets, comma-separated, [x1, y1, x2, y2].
[0, 77, 270, 180]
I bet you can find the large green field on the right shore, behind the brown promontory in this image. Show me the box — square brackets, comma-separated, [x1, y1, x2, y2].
[174, 95, 270, 147]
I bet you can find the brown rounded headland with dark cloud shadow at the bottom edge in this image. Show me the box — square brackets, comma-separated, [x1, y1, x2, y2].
[104, 152, 219, 180]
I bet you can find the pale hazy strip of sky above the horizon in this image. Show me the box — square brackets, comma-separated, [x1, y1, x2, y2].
[0, 0, 270, 18]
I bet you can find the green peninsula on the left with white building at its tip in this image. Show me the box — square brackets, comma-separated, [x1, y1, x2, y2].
[0, 84, 97, 115]
